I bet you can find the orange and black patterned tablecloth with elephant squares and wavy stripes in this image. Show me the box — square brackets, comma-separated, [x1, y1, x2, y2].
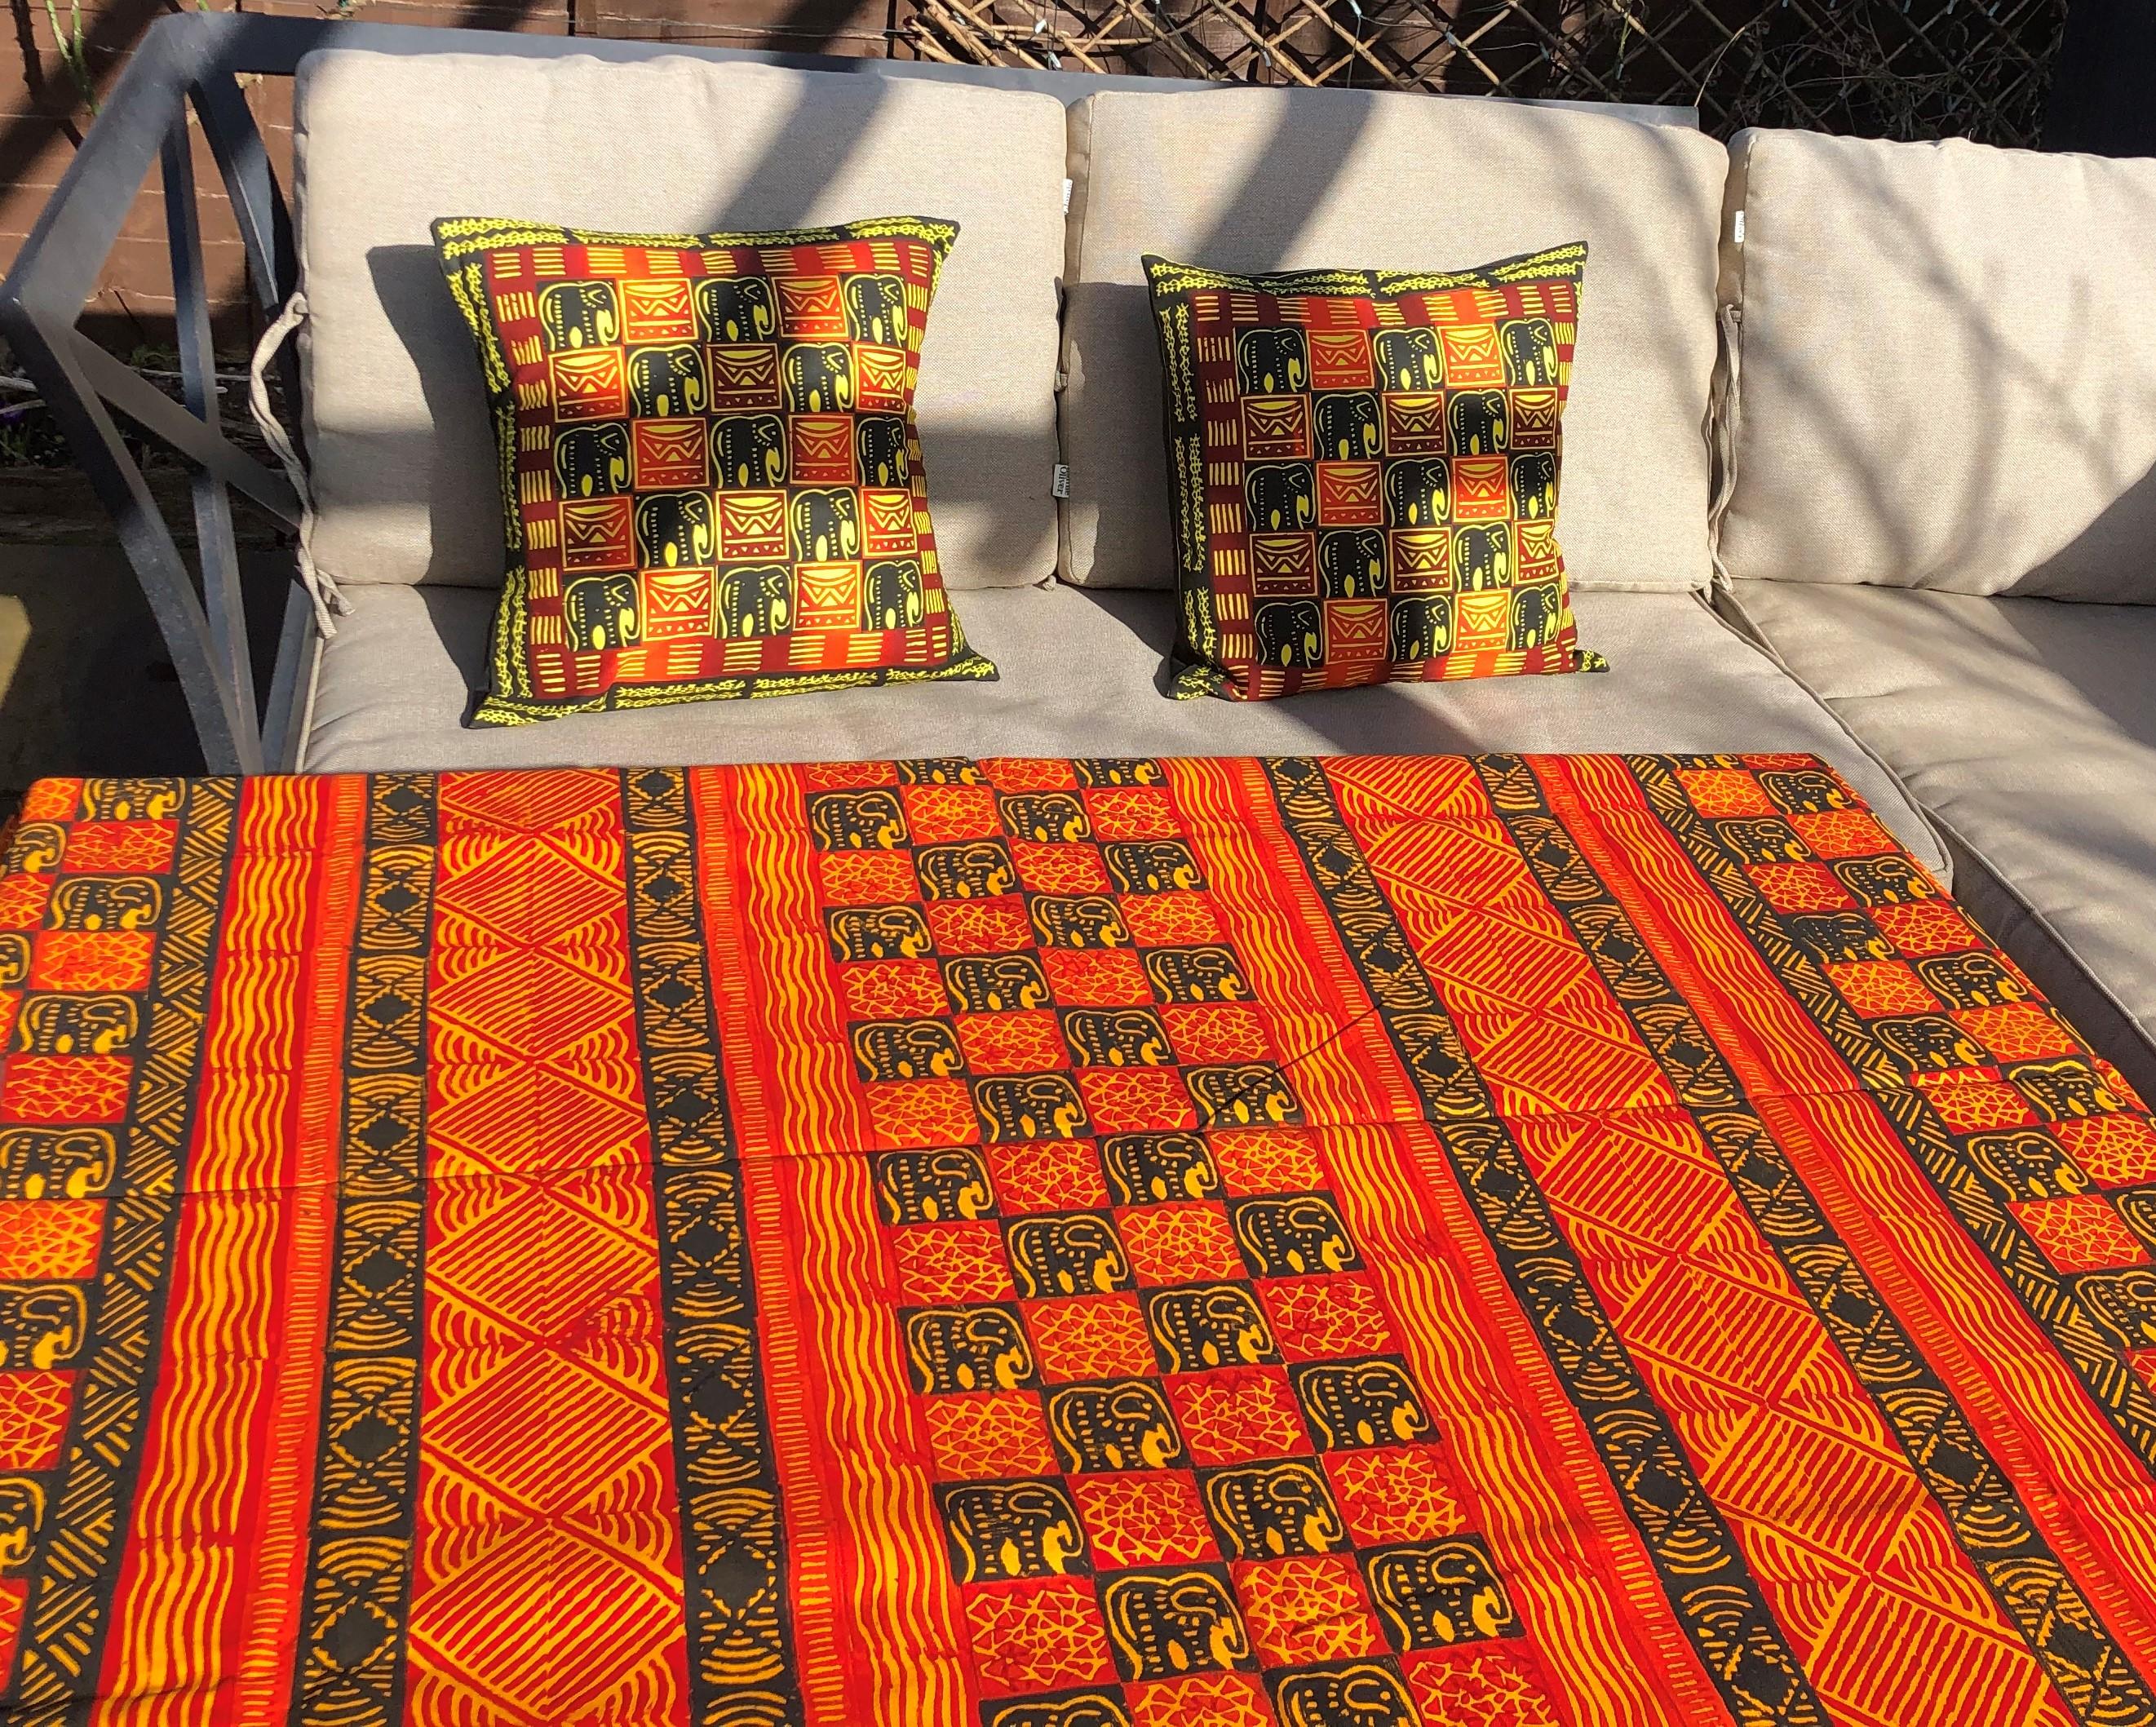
[0, 757, 2156, 1727]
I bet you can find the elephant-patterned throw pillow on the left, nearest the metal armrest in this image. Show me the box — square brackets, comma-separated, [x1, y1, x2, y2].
[433, 215, 996, 724]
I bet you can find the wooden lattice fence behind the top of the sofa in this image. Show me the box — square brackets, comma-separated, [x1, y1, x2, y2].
[899, 0, 2065, 144]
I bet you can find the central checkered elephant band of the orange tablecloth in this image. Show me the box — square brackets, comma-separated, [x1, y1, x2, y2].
[800, 755, 1561, 1727]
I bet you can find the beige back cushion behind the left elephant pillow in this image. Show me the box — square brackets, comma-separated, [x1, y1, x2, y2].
[295, 51, 1065, 589]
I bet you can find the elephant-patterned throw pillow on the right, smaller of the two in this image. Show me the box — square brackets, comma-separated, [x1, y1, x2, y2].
[1144, 244, 1606, 701]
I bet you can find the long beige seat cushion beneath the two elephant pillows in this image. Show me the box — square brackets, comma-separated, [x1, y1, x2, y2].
[306, 584, 1941, 865]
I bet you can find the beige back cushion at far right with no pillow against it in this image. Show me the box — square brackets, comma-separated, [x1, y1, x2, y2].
[1720, 131, 2156, 601]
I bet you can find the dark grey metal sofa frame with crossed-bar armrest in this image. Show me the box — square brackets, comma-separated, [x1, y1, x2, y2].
[0, 13, 1697, 774]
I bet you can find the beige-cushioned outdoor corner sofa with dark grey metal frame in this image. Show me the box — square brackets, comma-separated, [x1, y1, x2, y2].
[0, 17, 2156, 1089]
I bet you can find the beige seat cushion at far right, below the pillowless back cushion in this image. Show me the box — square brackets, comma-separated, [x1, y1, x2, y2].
[1738, 582, 2156, 1096]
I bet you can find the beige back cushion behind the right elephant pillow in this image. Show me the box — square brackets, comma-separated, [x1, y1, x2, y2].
[1060, 91, 1727, 589]
